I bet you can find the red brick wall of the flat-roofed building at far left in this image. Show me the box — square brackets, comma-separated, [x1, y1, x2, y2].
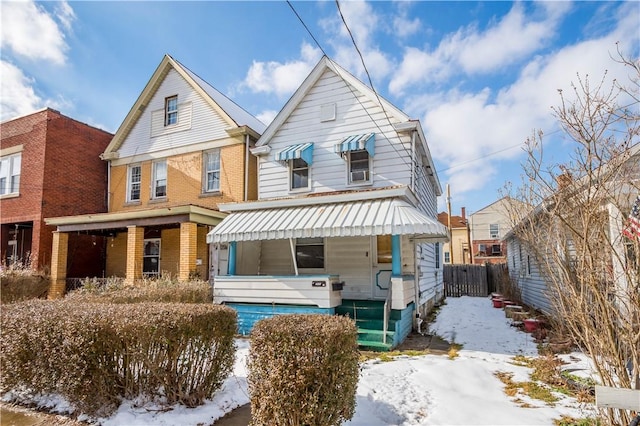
[0, 109, 113, 267]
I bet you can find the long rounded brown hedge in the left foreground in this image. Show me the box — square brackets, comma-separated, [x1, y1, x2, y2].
[0, 301, 236, 415]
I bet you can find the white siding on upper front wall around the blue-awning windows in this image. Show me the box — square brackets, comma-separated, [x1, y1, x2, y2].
[258, 70, 410, 199]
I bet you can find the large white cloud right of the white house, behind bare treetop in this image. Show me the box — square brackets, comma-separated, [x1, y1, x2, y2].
[420, 10, 640, 193]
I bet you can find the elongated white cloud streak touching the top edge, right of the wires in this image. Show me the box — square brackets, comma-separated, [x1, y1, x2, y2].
[389, 3, 567, 95]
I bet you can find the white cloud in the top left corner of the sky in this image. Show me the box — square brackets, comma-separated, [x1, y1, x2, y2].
[0, 1, 74, 64]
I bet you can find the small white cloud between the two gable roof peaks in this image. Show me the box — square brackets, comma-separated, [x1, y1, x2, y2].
[240, 43, 322, 96]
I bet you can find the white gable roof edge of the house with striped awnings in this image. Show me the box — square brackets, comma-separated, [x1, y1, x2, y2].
[256, 56, 409, 146]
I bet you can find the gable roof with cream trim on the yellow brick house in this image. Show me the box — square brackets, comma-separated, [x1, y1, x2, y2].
[102, 55, 266, 159]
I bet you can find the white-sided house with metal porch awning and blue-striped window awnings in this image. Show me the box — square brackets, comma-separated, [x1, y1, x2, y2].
[207, 57, 448, 349]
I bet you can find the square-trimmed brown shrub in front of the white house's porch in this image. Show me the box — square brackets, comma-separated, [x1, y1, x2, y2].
[248, 315, 359, 426]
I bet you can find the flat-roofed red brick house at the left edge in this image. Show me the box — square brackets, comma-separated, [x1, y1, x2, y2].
[0, 108, 113, 275]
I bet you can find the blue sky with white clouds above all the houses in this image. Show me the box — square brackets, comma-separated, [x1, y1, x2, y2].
[0, 0, 640, 214]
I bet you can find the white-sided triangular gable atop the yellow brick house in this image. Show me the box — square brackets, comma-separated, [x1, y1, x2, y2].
[118, 69, 230, 159]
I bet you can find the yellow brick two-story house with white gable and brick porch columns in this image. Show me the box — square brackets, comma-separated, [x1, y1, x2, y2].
[47, 55, 265, 296]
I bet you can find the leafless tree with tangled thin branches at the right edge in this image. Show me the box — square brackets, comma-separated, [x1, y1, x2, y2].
[506, 51, 640, 425]
